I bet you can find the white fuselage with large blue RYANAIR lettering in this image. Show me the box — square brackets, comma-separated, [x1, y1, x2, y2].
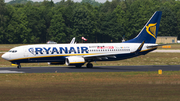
[2, 43, 156, 63]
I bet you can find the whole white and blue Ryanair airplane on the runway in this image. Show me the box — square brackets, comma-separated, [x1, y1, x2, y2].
[2, 11, 162, 68]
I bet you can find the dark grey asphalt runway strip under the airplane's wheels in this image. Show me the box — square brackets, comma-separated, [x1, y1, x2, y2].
[0, 65, 180, 73]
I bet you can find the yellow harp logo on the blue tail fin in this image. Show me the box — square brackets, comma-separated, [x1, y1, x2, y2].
[146, 23, 157, 39]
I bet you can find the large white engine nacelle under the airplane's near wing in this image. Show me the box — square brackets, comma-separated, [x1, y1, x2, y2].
[65, 56, 85, 66]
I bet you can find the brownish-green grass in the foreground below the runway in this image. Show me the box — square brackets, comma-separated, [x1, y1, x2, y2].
[0, 71, 180, 101]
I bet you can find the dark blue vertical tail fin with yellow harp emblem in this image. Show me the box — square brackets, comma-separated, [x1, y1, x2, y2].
[123, 11, 162, 43]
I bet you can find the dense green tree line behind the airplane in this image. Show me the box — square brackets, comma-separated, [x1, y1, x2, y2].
[0, 0, 180, 44]
